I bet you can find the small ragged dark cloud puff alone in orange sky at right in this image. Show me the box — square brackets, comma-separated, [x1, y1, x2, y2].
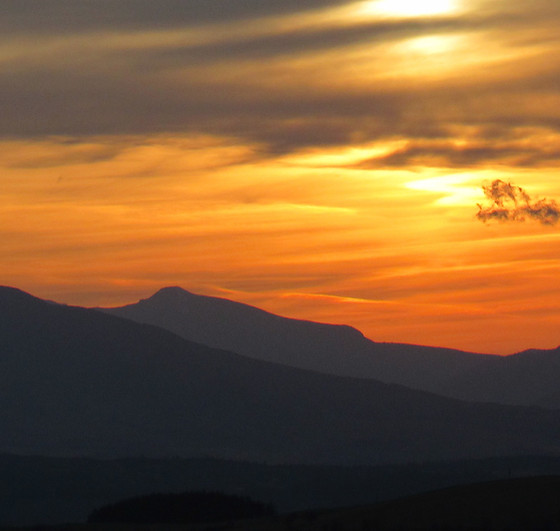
[476, 179, 560, 225]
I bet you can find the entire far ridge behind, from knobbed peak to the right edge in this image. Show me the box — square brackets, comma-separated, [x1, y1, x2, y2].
[103, 287, 560, 408]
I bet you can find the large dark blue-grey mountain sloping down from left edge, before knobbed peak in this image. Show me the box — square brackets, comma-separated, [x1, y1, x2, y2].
[0, 288, 560, 464]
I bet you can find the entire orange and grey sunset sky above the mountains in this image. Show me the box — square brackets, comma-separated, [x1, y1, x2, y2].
[0, 0, 560, 354]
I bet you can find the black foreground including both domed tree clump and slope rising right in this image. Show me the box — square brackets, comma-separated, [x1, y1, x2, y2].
[3, 475, 560, 531]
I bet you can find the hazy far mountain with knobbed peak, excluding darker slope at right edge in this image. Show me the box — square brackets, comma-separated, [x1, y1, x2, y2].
[102, 287, 495, 392]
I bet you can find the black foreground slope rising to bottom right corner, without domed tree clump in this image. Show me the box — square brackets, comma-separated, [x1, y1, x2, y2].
[6, 476, 560, 531]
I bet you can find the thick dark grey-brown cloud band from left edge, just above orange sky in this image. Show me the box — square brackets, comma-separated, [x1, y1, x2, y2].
[0, 62, 404, 154]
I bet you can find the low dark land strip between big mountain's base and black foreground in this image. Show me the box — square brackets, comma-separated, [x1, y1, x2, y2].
[0, 455, 560, 526]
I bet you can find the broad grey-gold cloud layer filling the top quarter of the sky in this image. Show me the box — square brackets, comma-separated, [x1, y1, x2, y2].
[0, 0, 560, 162]
